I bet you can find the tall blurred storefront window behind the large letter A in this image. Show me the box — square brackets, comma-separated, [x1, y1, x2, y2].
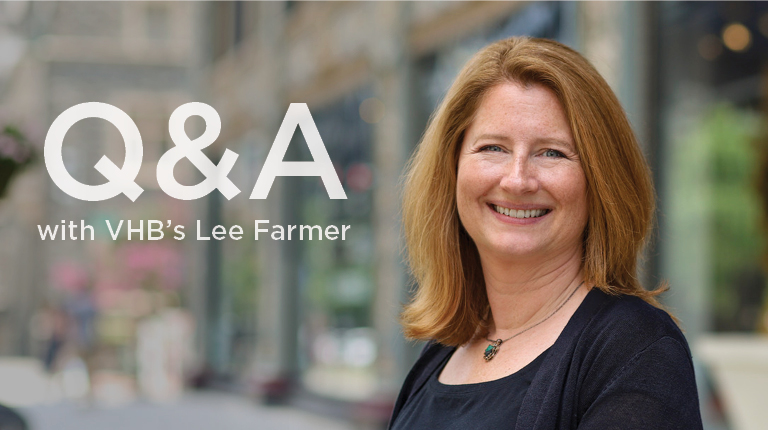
[286, 90, 377, 400]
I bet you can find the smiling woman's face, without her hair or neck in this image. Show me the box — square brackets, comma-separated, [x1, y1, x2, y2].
[456, 83, 588, 259]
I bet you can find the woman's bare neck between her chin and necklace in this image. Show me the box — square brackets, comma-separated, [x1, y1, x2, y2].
[481, 250, 583, 338]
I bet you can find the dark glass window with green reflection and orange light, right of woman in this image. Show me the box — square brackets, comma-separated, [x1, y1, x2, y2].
[659, 2, 768, 336]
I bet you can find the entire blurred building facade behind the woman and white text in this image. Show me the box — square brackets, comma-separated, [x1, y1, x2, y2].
[0, 2, 768, 426]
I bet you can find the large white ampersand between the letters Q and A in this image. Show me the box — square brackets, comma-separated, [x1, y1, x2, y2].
[157, 103, 240, 200]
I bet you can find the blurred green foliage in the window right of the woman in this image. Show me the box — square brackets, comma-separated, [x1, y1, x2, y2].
[692, 104, 765, 330]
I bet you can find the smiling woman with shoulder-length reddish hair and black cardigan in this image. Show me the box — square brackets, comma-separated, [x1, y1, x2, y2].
[390, 37, 702, 430]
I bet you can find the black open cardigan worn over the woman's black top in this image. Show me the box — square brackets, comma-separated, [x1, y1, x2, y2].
[390, 288, 702, 430]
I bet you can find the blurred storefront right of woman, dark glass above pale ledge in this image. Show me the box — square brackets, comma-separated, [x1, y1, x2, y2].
[654, 2, 768, 429]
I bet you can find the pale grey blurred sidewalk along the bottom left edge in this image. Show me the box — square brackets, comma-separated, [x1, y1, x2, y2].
[19, 392, 354, 430]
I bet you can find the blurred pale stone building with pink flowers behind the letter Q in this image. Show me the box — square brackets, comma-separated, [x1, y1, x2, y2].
[0, 2, 204, 402]
